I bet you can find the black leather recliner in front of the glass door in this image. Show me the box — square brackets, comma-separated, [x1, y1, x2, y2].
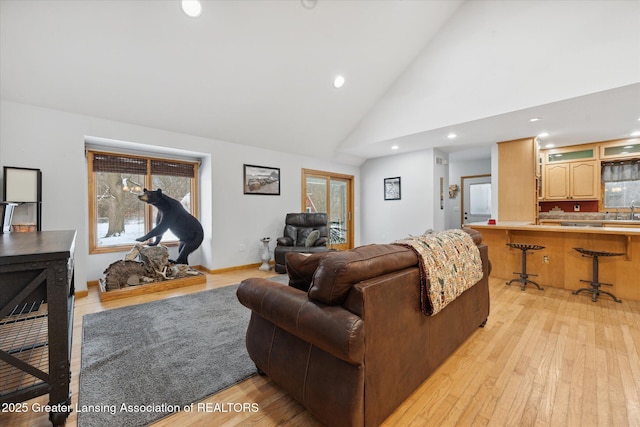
[273, 213, 329, 273]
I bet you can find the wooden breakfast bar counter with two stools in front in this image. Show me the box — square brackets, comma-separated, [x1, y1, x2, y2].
[466, 221, 640, 301]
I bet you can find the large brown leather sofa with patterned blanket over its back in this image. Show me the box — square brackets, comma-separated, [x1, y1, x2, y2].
[237, 232, 489, 426]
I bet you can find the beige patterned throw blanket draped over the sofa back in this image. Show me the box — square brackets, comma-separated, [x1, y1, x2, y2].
[394, 230, 483, 316]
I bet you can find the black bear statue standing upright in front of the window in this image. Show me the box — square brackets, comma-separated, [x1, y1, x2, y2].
[136, 188, 204, 264]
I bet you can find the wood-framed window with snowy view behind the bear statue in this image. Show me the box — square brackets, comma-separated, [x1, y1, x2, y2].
[88, 151, 198, 253]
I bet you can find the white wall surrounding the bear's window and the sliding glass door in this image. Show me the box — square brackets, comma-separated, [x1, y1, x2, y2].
[0, 100, 360, 289]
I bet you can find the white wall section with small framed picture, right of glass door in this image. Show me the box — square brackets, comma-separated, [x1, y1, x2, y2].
[360, 149, 448, 244]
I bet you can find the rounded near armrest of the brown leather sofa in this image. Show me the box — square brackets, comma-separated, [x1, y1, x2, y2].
[237, 278, 364, 365]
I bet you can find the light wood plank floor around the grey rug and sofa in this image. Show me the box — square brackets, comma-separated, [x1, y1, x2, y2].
[0, 269, 640, 427]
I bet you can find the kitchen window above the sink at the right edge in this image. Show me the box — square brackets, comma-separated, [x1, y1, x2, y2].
[602, 160, 640, 209]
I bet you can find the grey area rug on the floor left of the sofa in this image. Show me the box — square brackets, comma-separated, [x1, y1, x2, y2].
[80, 285, 256, 427]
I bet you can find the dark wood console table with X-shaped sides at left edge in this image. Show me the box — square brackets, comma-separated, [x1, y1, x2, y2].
[0, 231, 76, 425]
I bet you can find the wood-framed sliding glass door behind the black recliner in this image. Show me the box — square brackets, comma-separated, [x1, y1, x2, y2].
[302, 169, 353, 250]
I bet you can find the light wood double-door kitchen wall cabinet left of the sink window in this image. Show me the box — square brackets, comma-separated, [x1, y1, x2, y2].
[544, 160, 600, 200]
